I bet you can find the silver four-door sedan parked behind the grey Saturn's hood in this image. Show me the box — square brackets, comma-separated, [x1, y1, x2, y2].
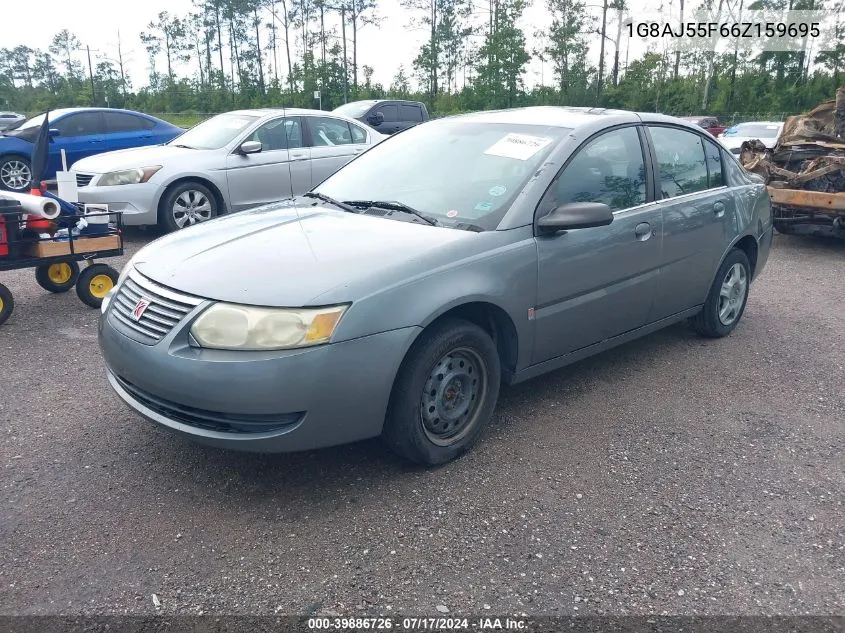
[71, 108, 388, 231]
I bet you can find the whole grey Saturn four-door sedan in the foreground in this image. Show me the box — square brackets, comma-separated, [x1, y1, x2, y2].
[99, 107, 772, 464]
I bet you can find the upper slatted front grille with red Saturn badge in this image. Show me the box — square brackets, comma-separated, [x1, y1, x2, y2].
[111, 270, 203, 345]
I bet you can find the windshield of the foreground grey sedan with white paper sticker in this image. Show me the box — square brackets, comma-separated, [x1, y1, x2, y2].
[314, 120, 570, 230]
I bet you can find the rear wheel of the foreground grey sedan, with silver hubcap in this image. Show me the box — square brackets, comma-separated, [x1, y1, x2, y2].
[690, 248, 751, 338]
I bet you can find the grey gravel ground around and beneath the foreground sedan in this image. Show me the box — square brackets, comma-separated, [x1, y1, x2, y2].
[0, 233, 845, 615]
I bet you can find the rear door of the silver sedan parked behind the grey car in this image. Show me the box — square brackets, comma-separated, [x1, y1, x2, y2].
[305, 116, 367, 187]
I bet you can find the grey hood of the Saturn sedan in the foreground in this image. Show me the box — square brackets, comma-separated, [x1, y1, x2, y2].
[139, 202, 483, 307]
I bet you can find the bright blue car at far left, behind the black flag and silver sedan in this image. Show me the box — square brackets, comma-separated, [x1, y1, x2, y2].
[0, 108, 185, 192]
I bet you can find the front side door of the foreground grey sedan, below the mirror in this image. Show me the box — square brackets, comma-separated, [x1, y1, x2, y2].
[532, 126, 663, 363]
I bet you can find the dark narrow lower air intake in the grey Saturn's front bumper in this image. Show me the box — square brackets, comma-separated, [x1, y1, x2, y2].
[112, 374, 305, 434]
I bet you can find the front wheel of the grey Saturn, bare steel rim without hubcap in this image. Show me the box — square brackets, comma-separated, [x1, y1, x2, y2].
[383, 319, 501, 466]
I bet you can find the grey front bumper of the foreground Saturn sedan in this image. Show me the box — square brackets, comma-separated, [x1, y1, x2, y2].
[99, 298, 419, 453]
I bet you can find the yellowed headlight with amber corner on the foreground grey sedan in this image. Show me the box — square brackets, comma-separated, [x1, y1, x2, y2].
[191, 303, 349, 350]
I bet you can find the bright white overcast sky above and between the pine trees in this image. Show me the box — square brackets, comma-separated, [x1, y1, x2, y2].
[0, 0, 669, 96]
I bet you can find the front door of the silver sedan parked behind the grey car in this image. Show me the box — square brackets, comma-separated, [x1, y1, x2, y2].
[226, 117, 310, 211]
